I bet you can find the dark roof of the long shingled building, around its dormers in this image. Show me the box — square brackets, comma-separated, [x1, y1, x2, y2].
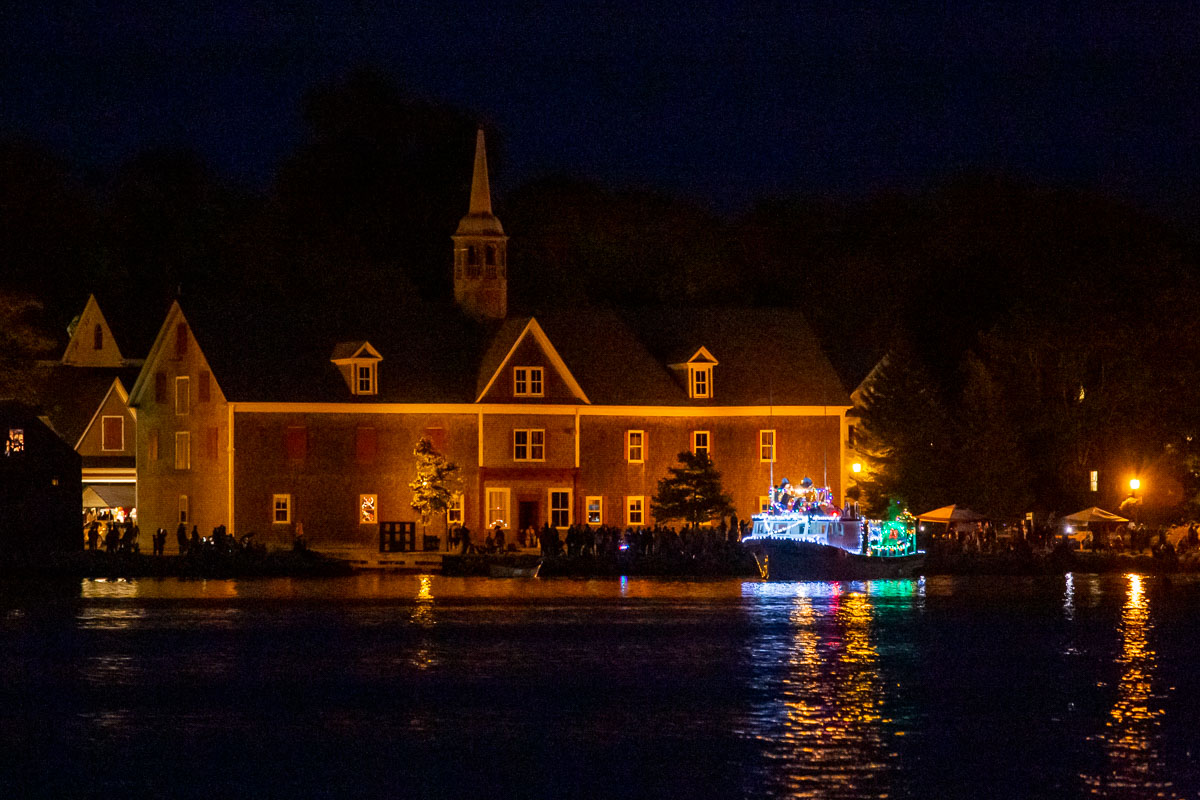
[147, 293, 851, 407]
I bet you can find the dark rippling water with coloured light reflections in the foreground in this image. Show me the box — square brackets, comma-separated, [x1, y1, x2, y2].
[0, 575, 1200, 798]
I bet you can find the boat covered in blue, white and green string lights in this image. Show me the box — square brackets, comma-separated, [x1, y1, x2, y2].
[742, 479, 925, 581]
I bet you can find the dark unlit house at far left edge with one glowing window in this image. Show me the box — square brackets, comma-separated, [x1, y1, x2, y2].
[0, 402, 83, 554]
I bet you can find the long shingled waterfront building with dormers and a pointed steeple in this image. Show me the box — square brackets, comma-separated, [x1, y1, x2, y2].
[130, 134, 850, 556]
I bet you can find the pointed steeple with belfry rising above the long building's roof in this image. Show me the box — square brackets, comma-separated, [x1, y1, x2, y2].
[451, 128, 509, 319]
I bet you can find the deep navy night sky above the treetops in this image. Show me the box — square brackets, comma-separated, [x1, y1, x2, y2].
[0, 0, 1200, 216]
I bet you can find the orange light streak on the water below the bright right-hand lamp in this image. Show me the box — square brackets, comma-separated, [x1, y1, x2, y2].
[1084, 575, 1178, 798]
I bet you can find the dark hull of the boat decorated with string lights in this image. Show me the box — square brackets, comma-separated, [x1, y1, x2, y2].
[745, 539, 925, 581]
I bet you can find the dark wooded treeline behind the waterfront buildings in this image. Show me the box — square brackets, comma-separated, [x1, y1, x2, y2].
[0, 71, 1200, 513]
